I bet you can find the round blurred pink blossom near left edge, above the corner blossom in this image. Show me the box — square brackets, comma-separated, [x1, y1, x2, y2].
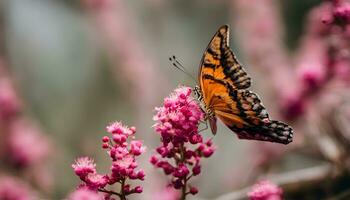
[8, 120, 51, 167]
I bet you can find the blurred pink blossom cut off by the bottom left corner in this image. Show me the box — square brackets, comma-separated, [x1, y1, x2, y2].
[0, 176, 38, 200]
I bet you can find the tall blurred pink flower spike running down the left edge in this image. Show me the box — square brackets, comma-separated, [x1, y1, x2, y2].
[0, 56, 52, 195]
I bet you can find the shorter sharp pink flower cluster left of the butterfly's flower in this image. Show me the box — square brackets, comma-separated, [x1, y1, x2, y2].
[72, 122, 145, 199]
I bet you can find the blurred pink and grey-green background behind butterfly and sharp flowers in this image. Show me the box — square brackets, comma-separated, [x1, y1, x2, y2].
[0, 0, 350, 199]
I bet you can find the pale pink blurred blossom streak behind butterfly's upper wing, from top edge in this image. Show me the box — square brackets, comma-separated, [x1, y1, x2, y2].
[230, 0, 295, 100]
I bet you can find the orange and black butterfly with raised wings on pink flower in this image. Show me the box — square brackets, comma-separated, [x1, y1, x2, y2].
[194, 25, 293, 144]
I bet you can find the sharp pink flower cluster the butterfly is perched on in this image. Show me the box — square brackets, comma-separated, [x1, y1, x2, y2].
[150, 87, 214, 197]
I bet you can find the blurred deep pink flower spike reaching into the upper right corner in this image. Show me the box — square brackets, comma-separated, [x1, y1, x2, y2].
[281, 0, 350, 119]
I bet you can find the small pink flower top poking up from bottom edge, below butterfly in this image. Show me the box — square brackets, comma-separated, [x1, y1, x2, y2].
[248, 180, 283, 200]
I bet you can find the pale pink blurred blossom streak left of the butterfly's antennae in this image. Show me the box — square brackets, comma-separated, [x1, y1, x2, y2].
[80, 0, 166, 121]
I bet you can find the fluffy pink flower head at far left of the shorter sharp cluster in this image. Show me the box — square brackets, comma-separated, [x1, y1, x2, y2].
[72, 157, 96, 179]
